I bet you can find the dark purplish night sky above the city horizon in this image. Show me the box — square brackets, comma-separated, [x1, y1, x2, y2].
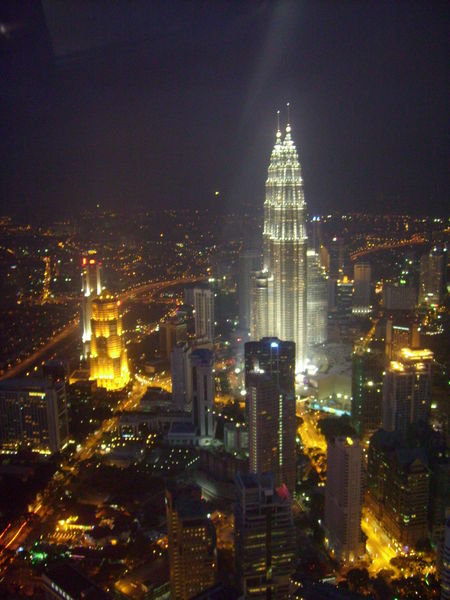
[0, 0, 450, 217]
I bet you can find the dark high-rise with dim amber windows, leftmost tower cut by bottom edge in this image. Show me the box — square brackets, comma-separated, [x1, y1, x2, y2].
[166, 483, 217, 600]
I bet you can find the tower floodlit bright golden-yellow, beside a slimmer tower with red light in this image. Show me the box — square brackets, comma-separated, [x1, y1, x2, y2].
[89, 291, 130, 391]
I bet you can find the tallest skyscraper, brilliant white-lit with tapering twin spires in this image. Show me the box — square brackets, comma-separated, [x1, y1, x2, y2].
[263, 115, 307, 369]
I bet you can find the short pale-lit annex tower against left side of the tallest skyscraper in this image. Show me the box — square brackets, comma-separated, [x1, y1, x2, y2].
[250, 271, 274, 340]
